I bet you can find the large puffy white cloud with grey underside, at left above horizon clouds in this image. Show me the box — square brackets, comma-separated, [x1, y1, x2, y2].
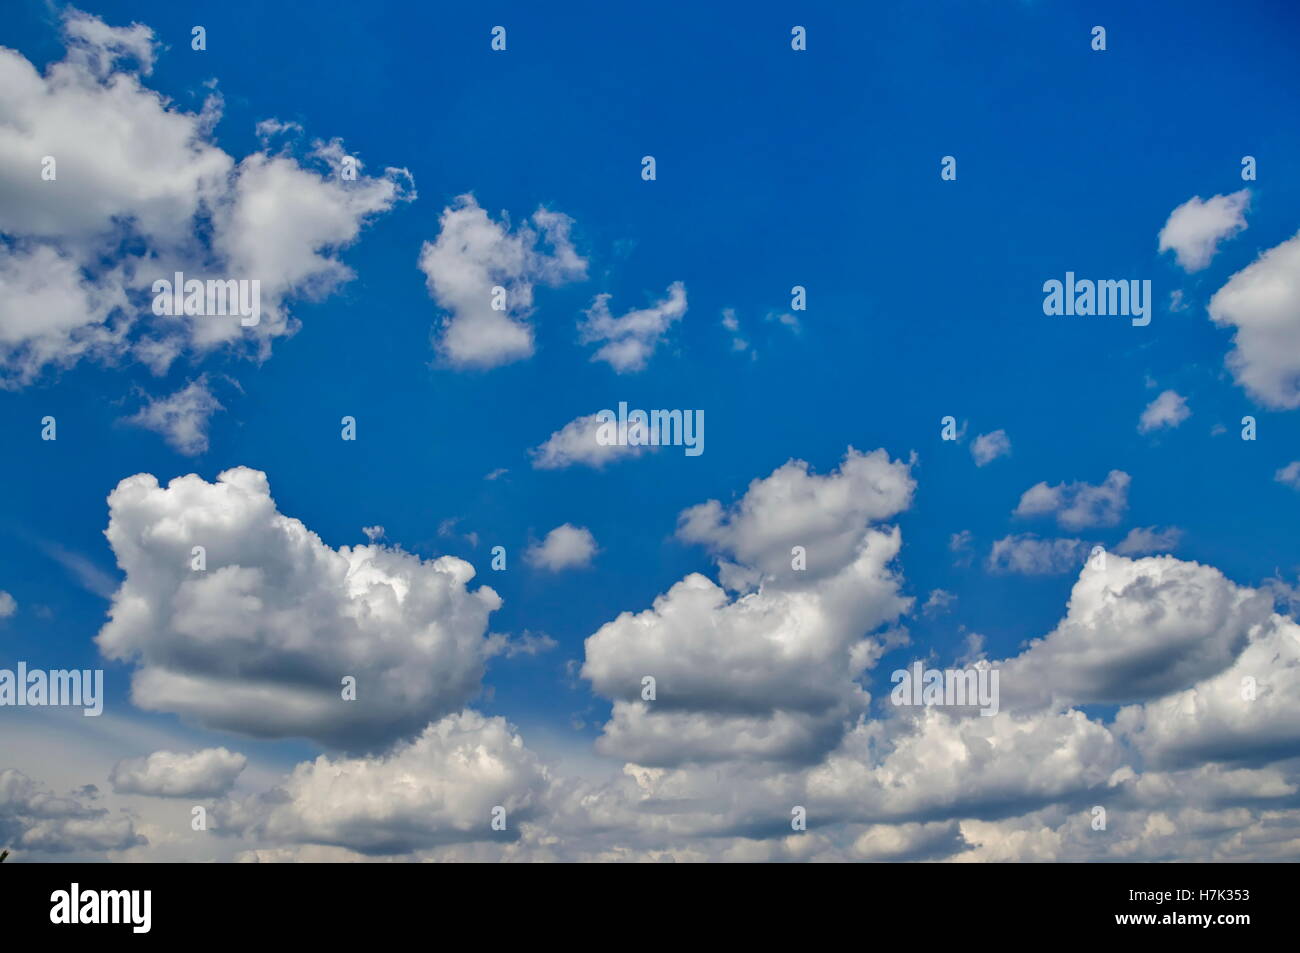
[96, 467, 503, 746]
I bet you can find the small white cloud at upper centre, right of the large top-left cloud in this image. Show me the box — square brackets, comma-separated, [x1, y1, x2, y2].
[420, 195, 586, 368]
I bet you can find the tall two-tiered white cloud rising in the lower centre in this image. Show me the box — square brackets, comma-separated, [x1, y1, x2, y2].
[581, 447, 914, 764]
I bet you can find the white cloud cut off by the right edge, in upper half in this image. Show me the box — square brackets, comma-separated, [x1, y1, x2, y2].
[1209, 235, 1300, 410]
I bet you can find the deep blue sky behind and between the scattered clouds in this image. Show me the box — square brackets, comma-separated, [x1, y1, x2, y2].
[0, 0, 1300, 863]
